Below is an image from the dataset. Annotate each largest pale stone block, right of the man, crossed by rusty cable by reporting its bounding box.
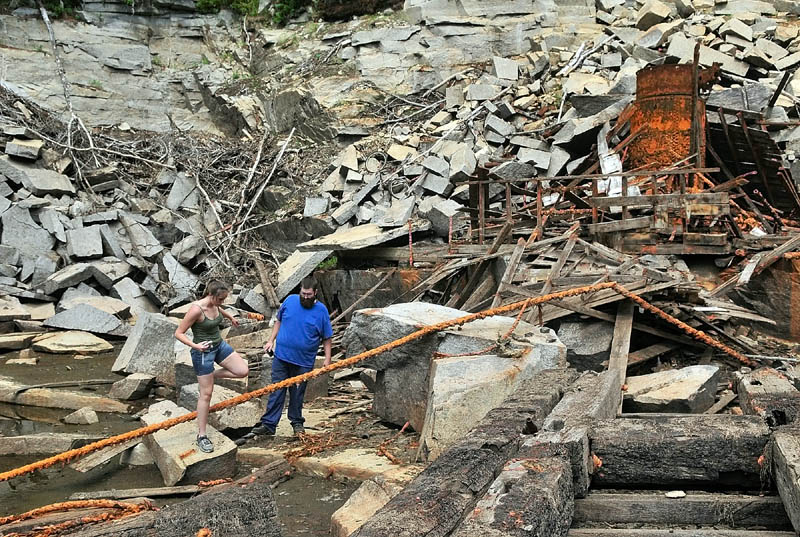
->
[344,302,566,457]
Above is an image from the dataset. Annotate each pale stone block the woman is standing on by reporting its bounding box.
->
[142,401,237,487]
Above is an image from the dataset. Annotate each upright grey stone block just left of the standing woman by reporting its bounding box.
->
[111,312,177,381]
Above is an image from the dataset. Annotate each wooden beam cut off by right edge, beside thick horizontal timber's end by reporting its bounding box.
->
[771,430,800,532]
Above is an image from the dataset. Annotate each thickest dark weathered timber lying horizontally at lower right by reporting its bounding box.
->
[590,414,770,488]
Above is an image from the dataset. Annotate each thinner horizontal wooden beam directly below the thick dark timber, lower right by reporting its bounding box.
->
[573,492,792,530]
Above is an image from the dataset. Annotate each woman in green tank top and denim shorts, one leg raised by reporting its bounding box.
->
[175,280,249,453]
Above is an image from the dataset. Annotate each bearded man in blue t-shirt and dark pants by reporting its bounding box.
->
[248,277,333,437]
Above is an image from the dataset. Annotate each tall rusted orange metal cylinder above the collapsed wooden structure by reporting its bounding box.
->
[626,64,706,170]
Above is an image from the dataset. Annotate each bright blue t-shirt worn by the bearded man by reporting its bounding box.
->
[275,295,333,367]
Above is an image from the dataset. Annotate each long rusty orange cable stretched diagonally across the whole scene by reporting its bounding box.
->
[0,282,754,482]
